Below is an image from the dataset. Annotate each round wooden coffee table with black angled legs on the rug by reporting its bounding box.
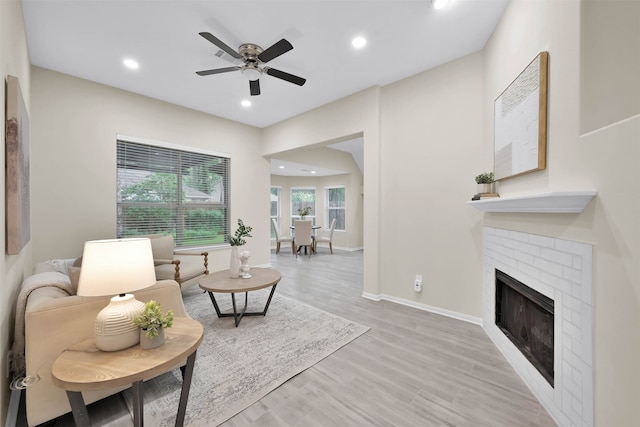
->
[200,268,282,328]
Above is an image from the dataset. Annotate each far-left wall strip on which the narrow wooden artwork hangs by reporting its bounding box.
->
[0,0,33,425]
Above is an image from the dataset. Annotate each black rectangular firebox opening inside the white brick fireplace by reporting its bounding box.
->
[496,270,553,386]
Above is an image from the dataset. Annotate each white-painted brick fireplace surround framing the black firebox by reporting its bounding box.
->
[483,227,593,427]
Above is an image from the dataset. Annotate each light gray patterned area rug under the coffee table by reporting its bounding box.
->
[126,290,369,426]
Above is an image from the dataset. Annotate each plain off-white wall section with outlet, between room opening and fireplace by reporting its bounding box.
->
[380,53,484,318]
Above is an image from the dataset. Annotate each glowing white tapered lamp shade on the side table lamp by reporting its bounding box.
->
[77,238,156,296]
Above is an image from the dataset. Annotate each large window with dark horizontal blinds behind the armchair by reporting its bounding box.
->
[117,140,229,248]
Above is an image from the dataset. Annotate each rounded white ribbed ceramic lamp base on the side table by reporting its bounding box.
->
[95,294,144,351]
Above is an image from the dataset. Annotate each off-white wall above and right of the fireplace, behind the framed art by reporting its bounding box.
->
[484,0,640,427]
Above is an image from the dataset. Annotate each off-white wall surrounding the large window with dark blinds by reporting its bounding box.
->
[32,67,270,271]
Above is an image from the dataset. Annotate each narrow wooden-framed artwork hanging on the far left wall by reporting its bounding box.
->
[5,76,31,255]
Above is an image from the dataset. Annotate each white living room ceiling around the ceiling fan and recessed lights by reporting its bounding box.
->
[23,0,508,176]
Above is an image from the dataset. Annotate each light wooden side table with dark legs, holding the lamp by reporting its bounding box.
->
[51,317,204,427]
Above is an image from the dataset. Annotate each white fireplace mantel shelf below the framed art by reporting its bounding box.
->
[467,191,596,213]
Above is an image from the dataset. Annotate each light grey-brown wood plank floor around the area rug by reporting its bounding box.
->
[23,247,556,427]
